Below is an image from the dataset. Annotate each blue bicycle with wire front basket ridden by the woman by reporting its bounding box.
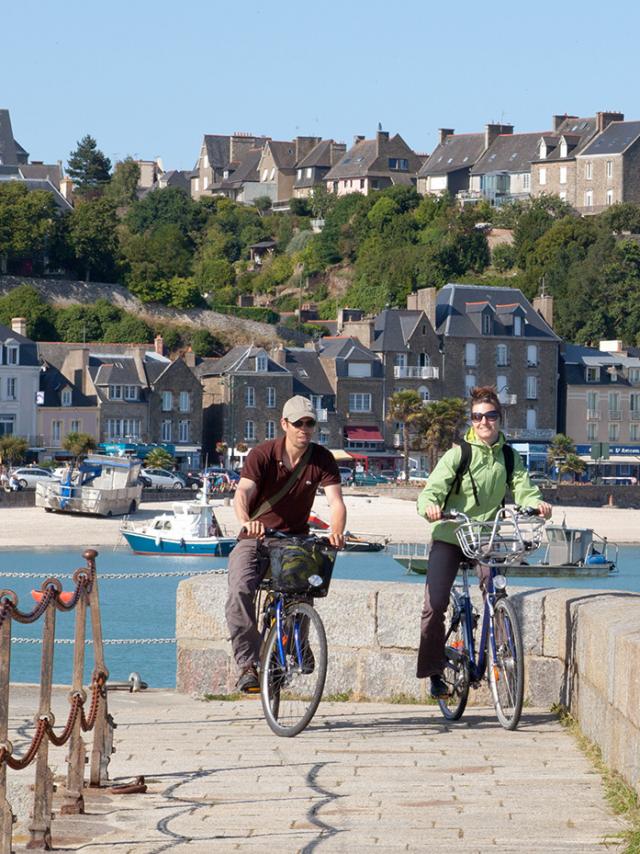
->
[438,507,544,730]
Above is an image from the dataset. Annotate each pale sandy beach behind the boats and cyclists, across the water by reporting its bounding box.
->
[0,495,640,552]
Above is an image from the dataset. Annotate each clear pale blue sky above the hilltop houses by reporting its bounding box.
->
[0,0,640,169]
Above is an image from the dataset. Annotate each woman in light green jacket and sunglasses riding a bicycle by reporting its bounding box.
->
[416,386,551,698]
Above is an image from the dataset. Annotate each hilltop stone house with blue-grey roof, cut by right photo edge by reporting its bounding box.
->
[576,121,640,215]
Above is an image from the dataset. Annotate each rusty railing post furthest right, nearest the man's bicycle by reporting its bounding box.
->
[82,549,113,786]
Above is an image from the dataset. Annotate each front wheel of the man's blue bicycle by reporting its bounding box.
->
[260,602,327,737]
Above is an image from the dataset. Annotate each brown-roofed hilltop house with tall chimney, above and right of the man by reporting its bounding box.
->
[325,130,424,196]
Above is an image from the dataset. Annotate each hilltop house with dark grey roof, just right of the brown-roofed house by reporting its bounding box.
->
[417,124,513,196]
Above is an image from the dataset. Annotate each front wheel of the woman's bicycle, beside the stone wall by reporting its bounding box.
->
[489,599,524,729]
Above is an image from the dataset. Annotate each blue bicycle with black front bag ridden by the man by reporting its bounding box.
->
[256,530,336,737]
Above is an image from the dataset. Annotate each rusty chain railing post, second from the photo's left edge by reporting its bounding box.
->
[27,592,60,851]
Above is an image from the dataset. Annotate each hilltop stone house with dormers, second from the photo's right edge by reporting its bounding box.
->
[531,112,624,207]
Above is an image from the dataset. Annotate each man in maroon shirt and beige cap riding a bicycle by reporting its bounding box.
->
[225,395,347,693]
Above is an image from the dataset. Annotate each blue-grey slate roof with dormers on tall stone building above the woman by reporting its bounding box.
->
[436,284,560,341]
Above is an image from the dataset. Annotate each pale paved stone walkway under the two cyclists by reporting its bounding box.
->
[9,689,622,854]
